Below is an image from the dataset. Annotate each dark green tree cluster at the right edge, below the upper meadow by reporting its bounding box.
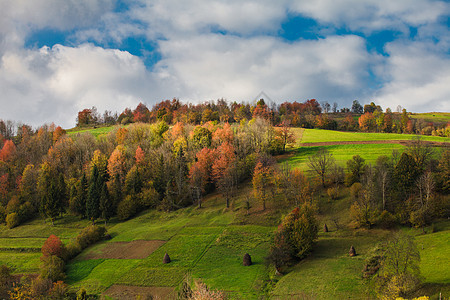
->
[309,137,450,228]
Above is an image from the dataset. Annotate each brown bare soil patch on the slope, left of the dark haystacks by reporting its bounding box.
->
[86,240,166,259]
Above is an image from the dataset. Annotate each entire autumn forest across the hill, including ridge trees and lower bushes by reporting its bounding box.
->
[0,99,450,299]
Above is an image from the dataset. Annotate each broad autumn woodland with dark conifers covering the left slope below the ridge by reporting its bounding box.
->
[0,118,293,228]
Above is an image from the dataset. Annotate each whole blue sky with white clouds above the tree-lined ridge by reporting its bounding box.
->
[0,0,450,128]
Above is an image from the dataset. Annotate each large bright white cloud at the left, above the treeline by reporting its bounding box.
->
[0,44,154,127]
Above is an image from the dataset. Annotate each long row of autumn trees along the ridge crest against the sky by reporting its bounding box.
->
[73,99,450,136]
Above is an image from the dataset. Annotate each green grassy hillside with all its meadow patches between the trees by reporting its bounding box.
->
[0,128,450,299]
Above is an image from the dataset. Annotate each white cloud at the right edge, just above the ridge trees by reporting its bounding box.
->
[375,42,450,112]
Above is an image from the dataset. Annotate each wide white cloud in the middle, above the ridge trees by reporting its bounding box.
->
[155,35,371,101]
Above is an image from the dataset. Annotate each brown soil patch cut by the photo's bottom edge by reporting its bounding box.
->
[103,285,177,300]
